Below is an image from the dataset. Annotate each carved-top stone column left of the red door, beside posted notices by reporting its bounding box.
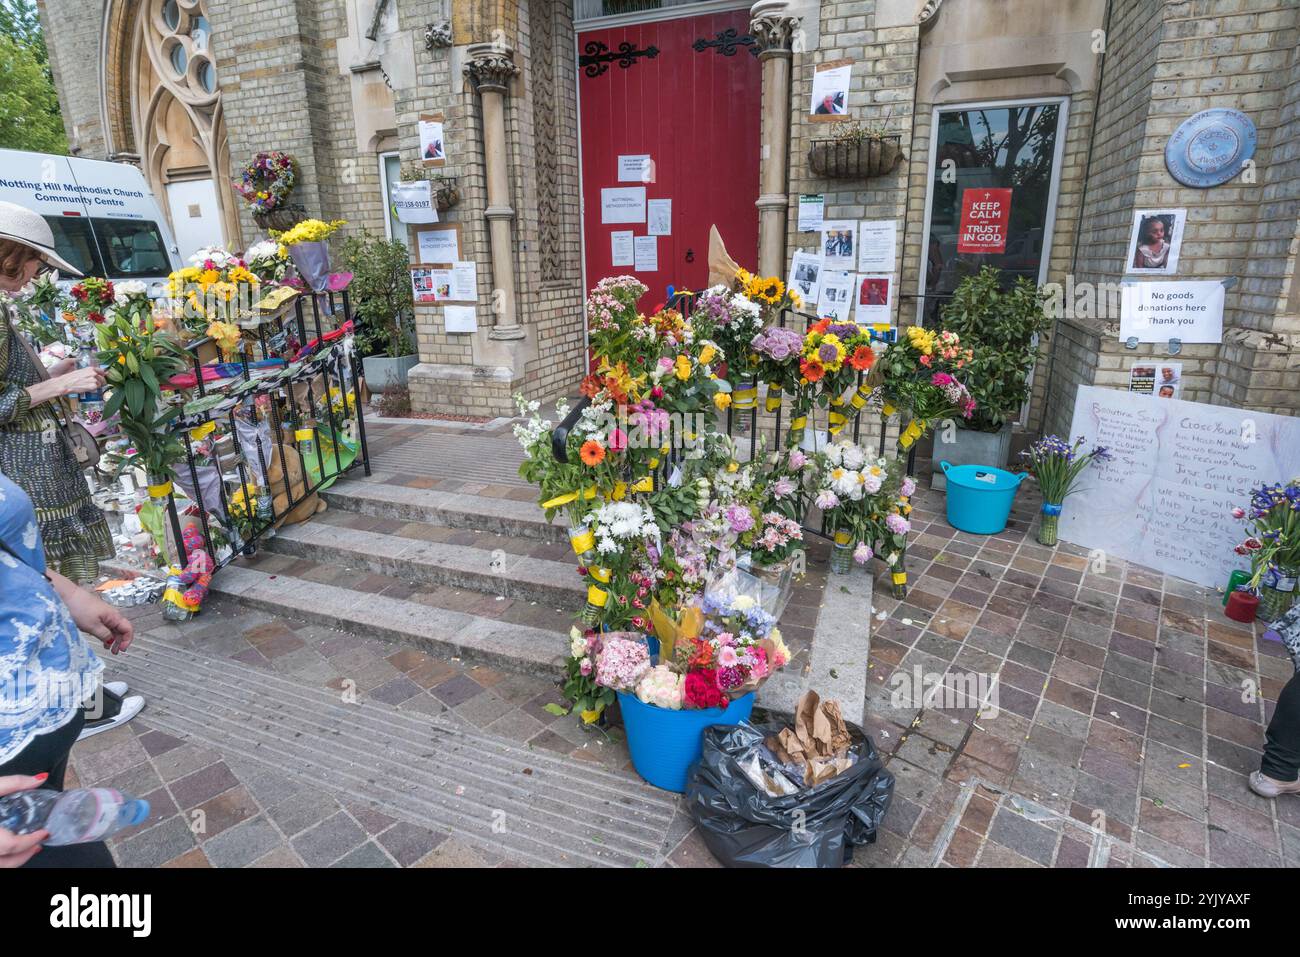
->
[464,43,524,339]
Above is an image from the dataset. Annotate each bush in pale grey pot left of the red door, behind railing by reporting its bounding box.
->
[343,231,420,393]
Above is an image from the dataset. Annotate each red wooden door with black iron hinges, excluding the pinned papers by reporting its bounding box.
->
[577,9,761,308]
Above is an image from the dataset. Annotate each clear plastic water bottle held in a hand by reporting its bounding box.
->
[0,788,150,848]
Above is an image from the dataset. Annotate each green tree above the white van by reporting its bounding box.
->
[0,0,68,155]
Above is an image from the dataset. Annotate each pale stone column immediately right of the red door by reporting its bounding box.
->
[749,0,798,276]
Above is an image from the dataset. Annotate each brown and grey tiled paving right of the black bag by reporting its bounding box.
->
[863,460,1300,866]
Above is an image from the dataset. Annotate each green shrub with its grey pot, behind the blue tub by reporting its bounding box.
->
[931,265,1050,489]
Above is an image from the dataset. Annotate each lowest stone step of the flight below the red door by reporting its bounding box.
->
[212,563,568,677]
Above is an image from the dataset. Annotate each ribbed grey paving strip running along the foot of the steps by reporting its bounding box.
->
[114,634,677,867]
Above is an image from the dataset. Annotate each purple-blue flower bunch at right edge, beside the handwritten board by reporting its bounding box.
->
[1232,479,1300,622]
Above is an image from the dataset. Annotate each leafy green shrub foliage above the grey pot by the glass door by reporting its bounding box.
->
[940,267,1050,432]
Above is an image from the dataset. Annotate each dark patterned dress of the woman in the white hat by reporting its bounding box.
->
[0,321,114,581]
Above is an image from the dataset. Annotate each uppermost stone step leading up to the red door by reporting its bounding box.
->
[321,476,568,542]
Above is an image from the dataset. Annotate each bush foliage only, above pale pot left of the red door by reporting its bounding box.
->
[342,230,415,359]
